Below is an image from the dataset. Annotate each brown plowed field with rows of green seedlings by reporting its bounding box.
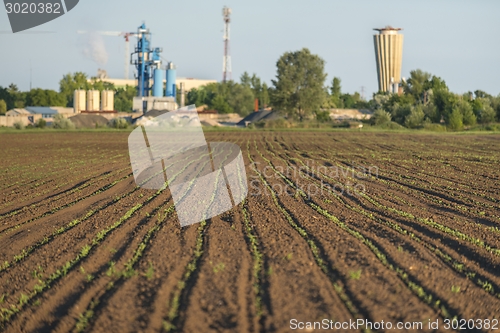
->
[0,131,500,332]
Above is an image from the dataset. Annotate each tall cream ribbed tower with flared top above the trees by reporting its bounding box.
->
[373,26,403,93]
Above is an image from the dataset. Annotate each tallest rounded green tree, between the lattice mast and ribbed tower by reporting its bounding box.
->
[272,48,326,121]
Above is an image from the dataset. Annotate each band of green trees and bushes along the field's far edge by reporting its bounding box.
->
[0,48,500,130]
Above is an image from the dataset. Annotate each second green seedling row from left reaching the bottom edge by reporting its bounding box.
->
[162,144,235,332]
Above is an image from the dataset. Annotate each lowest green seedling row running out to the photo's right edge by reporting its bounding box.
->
[274,140,500,298]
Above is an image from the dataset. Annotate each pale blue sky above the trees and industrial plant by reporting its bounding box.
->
[0,0,500,96]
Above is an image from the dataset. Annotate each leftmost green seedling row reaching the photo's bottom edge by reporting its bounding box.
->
[75,147,230,332]
